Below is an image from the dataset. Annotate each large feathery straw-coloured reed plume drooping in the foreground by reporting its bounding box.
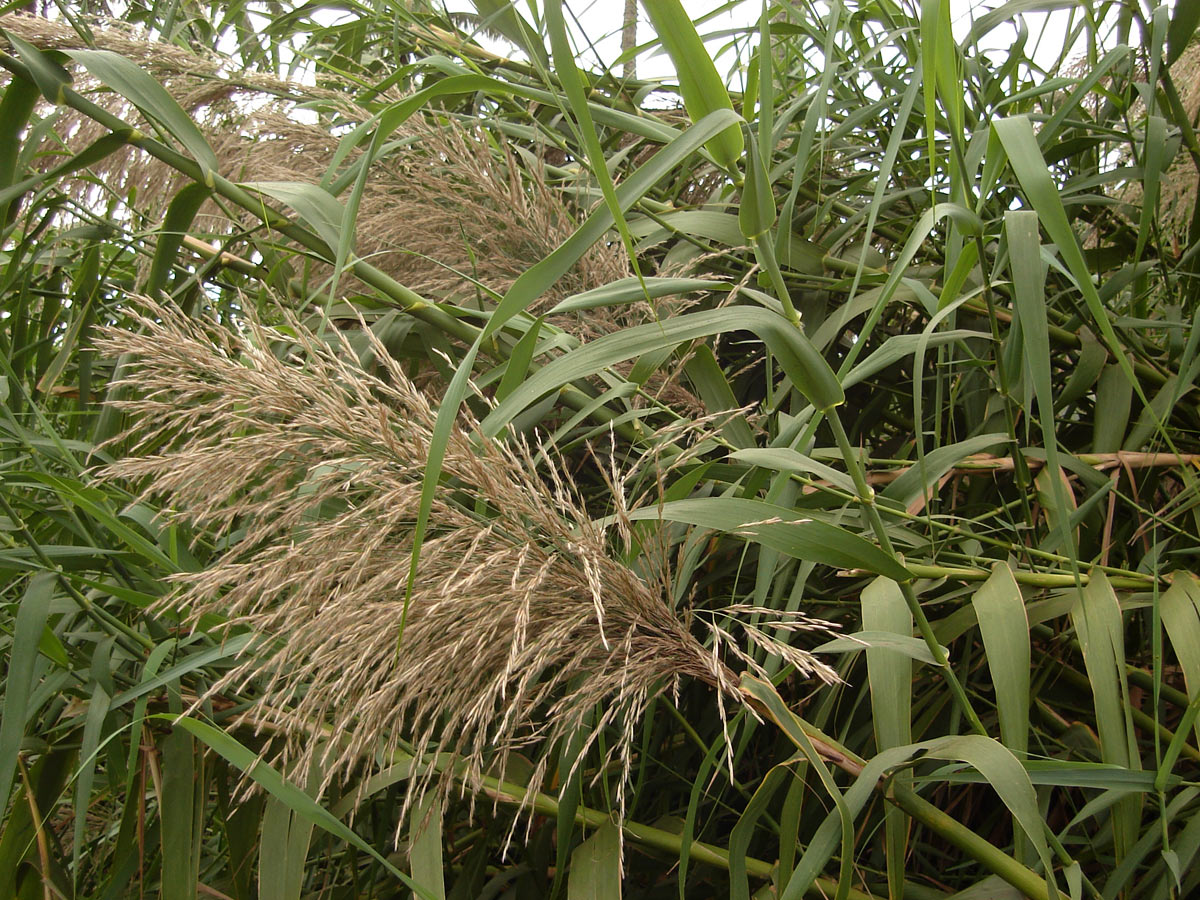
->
[93,301,830,835]
